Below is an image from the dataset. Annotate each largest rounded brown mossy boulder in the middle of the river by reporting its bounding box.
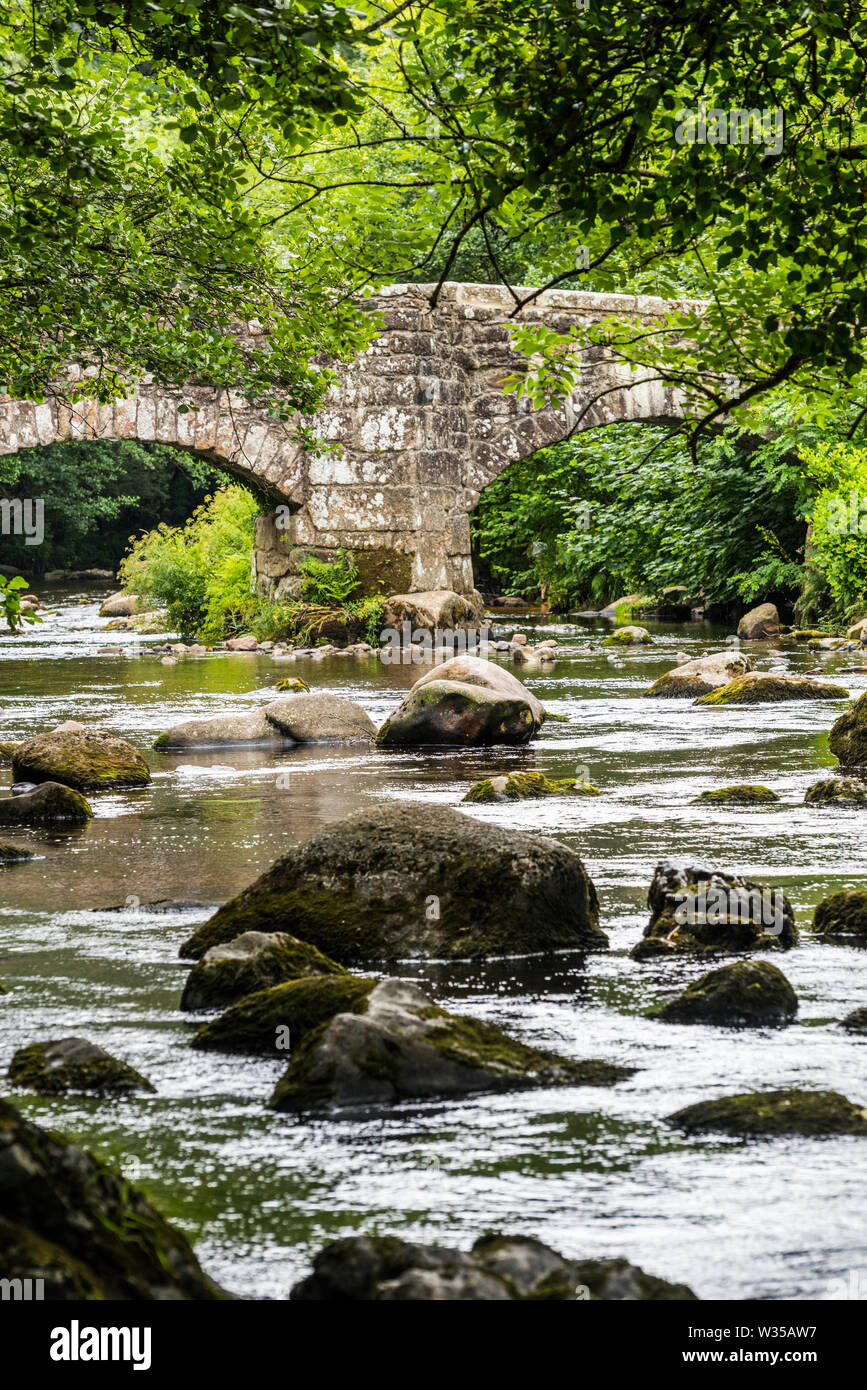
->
[181,802,607,965]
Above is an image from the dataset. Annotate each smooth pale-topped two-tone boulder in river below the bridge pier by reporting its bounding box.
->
[377,656,545,748]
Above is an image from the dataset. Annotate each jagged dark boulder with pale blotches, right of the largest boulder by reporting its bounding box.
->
[629,860,798,960]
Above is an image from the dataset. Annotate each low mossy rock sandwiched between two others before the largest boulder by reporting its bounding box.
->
[193,972,377,1056]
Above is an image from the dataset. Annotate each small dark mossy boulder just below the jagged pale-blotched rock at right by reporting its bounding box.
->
[653,960,798,1027]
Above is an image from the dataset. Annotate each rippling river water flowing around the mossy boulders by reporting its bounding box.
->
[0,596,867,1300]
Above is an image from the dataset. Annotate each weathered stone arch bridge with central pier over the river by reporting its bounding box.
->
[0,284,691,594]
